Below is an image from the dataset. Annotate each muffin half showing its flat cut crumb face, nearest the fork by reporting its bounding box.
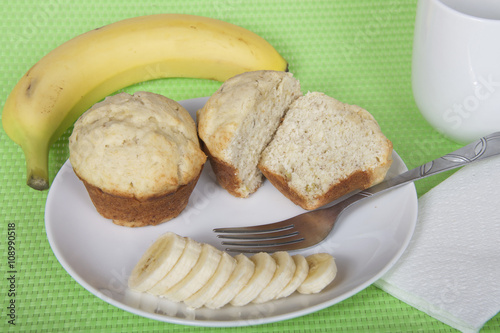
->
[258,92,392,210]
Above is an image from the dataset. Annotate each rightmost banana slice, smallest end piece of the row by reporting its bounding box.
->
[297,253,337,294]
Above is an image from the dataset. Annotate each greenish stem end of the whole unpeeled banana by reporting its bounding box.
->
[22,142,49,191]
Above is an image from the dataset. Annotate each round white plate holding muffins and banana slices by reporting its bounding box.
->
[45,98,417,326]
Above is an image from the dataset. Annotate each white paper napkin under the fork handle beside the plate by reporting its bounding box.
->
[375,156,500,332]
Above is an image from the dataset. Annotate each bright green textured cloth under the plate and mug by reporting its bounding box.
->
[0,0,500,332]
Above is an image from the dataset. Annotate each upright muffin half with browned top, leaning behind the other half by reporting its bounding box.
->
[197,71,302,197]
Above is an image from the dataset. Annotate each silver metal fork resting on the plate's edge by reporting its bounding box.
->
[213,132,500,253]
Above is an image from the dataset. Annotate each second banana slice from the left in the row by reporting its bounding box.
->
[148,237,201,296]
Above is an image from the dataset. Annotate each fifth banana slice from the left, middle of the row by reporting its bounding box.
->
[205,254,255,309]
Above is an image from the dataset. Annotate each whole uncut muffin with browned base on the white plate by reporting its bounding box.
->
[69,92,206,227]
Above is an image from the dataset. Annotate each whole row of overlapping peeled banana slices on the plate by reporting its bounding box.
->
[129,232,337,309]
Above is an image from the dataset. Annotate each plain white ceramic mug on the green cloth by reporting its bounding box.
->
[412,0,500,143]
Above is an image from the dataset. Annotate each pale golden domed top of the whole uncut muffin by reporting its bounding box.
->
[69,92,206,199]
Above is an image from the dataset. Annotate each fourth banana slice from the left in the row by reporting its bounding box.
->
[184,252,236,309]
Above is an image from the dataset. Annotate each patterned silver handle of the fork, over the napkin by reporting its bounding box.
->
[336,132,500,207]
